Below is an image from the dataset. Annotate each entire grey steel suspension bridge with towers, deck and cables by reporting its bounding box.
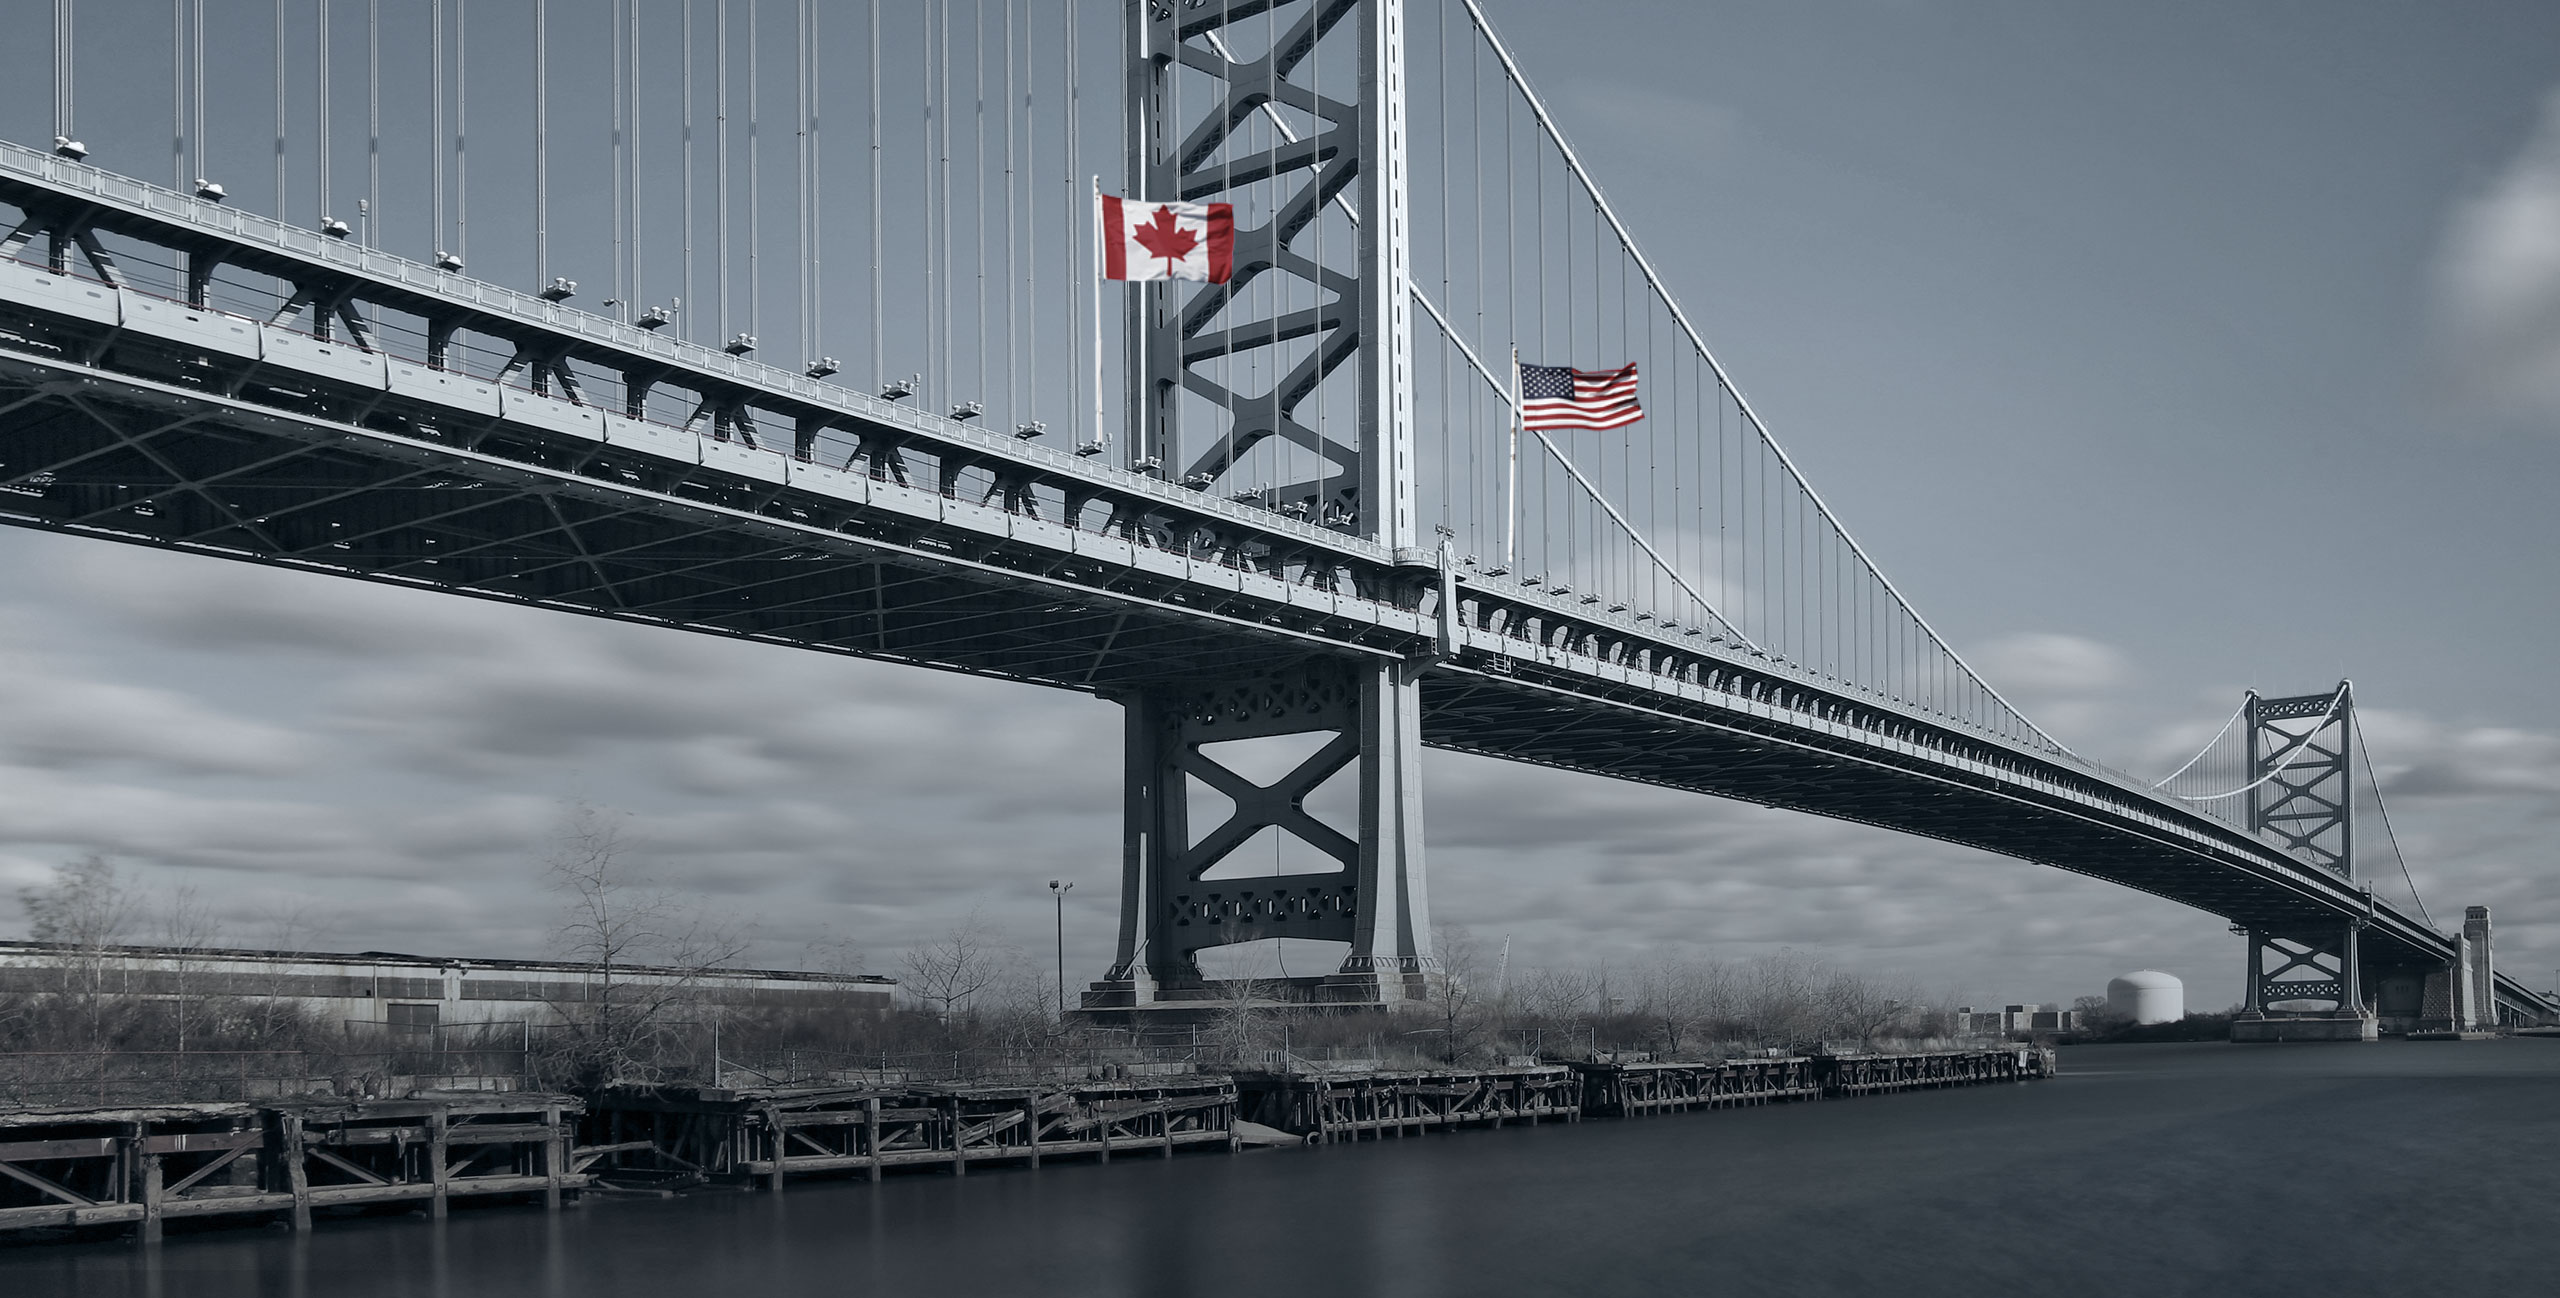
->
[0,0,2550,1037]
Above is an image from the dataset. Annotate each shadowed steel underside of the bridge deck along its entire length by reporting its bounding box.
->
[0,286,2529,1024]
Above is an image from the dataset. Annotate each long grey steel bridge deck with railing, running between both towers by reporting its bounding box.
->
[0,146,2529,1004]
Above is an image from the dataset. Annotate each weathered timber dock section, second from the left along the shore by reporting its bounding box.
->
[581,1075,1236,1190]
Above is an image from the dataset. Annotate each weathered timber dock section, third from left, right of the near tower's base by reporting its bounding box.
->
[1236,1065,1582,1144]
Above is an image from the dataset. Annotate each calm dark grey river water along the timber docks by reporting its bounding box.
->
[0,1039,2560,1298]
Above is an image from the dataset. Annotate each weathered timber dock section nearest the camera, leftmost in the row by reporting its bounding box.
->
[0,1093,586,1242]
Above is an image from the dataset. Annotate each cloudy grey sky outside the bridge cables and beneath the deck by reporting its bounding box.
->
[0,0,2560,1006]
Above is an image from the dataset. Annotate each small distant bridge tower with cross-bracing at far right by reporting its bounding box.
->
[2232,681,2375,1042]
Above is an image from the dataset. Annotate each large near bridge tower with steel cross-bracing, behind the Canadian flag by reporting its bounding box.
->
[1083,0,1444,1014]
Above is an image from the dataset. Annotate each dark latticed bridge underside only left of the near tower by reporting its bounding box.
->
[0,358,1339,691]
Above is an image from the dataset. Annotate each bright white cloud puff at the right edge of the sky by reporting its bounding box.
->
[2437,90,2560,433]
